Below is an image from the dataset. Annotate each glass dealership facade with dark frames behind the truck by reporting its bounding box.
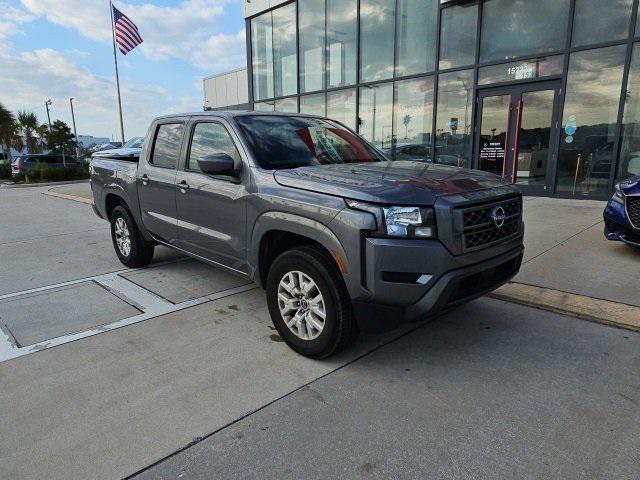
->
[247,0,640,198]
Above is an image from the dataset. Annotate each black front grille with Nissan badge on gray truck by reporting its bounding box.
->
[462,197,522,252]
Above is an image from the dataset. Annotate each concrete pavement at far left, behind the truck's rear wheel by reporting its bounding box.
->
[0,184,181,295]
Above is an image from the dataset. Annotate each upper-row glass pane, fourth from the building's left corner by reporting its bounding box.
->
[327,0,358,88]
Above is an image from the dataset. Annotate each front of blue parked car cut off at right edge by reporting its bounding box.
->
[604,175,640,247]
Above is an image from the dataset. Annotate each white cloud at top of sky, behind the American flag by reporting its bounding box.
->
[18,0,246,73]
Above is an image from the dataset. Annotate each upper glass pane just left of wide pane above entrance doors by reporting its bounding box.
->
[440,2,478,69]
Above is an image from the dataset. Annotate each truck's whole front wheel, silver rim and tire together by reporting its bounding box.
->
[266,246,358,358]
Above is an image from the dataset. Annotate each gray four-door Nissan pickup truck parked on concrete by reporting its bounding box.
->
[90,112,524,358]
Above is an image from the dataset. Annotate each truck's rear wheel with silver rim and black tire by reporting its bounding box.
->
[111,205,154,268]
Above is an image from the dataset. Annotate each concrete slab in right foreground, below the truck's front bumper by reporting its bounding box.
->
[135,299,640,480]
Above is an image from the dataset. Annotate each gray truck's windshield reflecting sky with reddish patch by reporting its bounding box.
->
[236,115,386,170]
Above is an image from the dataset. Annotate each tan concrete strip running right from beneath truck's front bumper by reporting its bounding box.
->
[488,282,640,332]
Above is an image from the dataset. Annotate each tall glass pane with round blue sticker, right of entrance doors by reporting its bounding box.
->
[556,45,627,195]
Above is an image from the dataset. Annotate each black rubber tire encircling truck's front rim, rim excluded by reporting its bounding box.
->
[266,246,359,359]
